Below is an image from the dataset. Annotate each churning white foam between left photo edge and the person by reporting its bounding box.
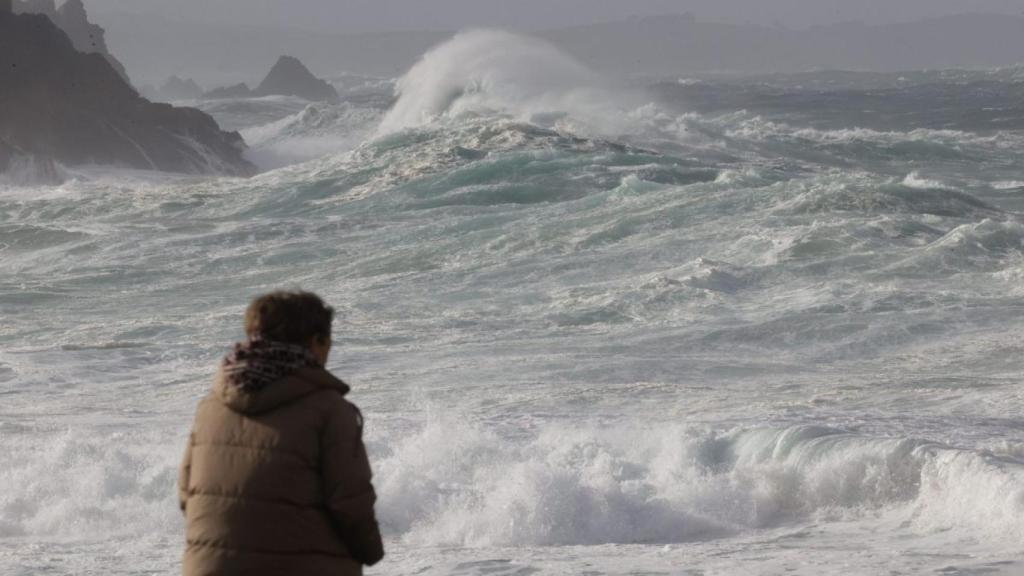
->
[0,424,181,540]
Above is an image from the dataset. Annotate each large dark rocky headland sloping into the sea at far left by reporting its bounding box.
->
[0,13,255,175]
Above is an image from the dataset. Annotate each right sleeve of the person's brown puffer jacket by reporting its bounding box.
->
[322,401,384,566]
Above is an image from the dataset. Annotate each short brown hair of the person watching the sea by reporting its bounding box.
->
[246,290,334,345]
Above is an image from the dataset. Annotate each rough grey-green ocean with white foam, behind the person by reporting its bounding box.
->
[0,31,1024,576]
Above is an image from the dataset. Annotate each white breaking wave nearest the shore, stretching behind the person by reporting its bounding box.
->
[0,419,1024,547]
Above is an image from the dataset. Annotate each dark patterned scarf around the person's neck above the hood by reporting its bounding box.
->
[221,340,319,393]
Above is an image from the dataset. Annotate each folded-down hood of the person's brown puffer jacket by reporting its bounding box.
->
[213,367,351,415]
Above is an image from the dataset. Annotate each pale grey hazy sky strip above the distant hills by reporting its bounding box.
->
[90,0,1024,33]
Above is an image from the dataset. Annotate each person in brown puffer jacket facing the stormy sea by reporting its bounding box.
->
[178,291,384,576]
